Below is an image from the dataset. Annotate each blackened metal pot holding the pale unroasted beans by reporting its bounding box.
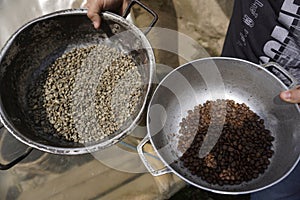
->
[0,8,155,155]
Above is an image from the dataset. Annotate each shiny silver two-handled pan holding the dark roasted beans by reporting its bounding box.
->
[138,58,300,194]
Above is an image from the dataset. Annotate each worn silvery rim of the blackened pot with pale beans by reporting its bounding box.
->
[0,9,156,155]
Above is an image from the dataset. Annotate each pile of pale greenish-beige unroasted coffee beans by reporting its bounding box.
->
[28,45,143,144]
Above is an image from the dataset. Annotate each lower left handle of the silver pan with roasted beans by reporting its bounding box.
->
[137,136,172,176]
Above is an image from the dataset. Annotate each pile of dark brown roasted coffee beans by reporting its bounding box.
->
[178,99,274,186]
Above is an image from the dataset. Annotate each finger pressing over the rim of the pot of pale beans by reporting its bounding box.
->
[86,0,105,29]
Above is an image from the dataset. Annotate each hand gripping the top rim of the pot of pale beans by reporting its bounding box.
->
[86,0,129,29]
